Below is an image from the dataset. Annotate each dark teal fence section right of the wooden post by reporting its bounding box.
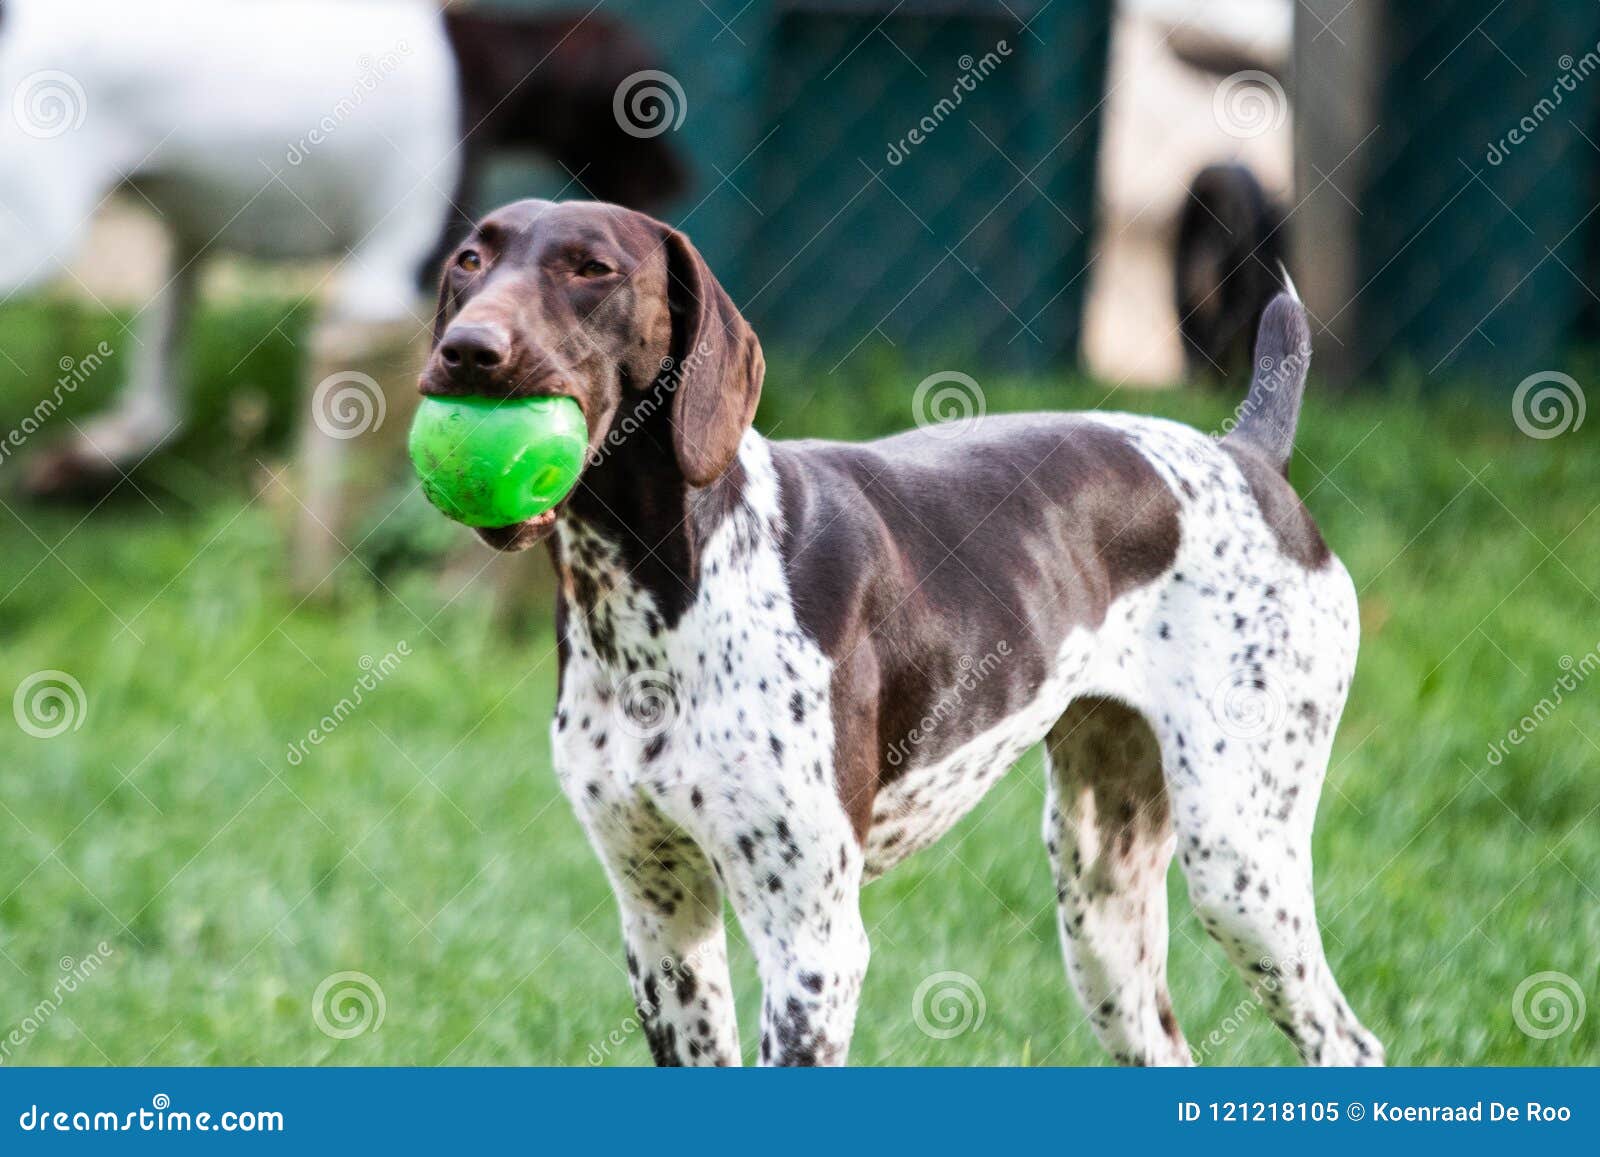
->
[1331,0,1600,387]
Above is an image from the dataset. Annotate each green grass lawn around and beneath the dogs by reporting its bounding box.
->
[0,300,1600,1064]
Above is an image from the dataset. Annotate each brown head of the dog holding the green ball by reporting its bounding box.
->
[421,200,765,549]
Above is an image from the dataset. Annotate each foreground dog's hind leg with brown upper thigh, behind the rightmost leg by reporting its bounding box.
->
[1045,699,1189,1064]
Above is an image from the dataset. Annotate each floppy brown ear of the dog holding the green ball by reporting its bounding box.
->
[664,229,766,486]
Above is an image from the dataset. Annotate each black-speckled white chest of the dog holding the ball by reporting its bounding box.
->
[552,435,834,823]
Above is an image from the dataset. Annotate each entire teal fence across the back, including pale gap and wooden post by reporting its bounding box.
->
[476,0,1600,387]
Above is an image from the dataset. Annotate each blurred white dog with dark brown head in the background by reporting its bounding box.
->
[0,0,682,584]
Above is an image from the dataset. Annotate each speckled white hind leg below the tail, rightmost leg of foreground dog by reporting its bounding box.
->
[1155,570,1384,1064]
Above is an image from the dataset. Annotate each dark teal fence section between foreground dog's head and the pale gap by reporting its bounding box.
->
[486,0,1110,368]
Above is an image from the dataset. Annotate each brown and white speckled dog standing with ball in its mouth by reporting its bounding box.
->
[421,202,1382,1064]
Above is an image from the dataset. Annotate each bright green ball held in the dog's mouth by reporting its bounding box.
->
[410,397,589,526]
